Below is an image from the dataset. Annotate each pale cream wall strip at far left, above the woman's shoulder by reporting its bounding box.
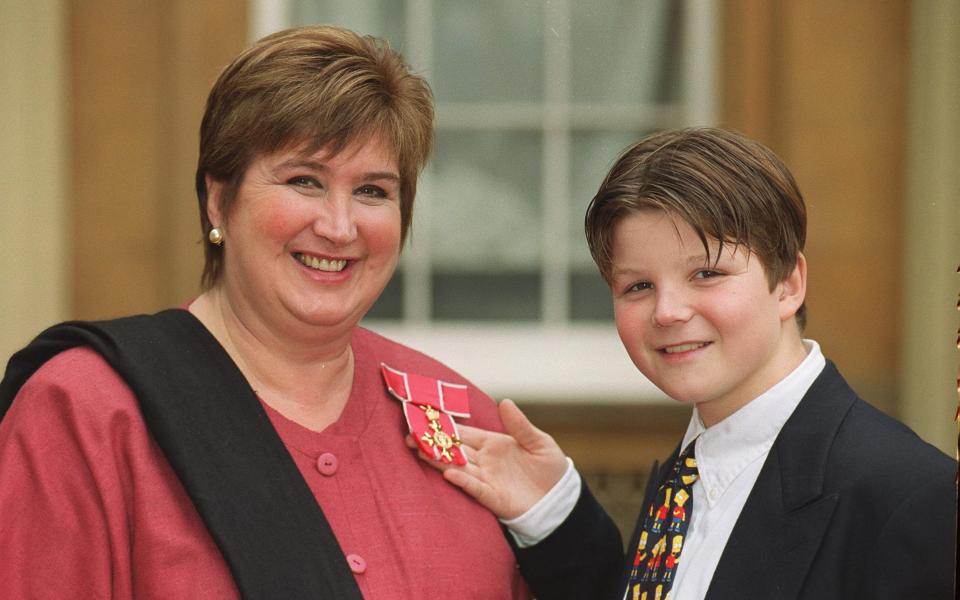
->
[0,0,72,364]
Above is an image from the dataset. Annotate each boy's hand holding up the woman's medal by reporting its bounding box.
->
[407,400,567,519]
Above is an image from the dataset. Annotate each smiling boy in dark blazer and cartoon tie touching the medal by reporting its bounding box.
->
[428,129,956,600]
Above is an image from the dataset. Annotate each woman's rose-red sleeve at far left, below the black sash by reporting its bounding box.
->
[0,354,120,598]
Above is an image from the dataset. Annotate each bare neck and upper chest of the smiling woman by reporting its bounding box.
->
[189,288,354,431]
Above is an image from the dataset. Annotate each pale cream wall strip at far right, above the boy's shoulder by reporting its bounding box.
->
[900,0,960,455]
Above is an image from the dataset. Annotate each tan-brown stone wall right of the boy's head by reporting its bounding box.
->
[722,0,909,412]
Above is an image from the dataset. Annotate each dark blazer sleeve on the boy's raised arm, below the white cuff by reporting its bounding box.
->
[507,482,623,600]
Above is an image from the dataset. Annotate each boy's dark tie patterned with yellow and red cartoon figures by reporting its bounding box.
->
[627,440,699,600]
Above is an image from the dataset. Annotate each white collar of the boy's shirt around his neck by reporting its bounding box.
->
[681,340,826,506]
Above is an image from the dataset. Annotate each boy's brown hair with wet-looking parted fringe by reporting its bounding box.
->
[584,128,807,329]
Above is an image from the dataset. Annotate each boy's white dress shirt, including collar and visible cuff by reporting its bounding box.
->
[503,340,826,600]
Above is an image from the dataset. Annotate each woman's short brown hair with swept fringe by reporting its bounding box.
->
[196,26,433,287]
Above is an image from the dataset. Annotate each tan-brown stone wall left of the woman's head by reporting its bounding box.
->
[68,0,246,318]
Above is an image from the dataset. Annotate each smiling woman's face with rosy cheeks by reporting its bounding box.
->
[208,137,400,335]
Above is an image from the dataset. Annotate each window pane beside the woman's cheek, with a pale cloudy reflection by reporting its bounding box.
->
[434,131,543,272]
